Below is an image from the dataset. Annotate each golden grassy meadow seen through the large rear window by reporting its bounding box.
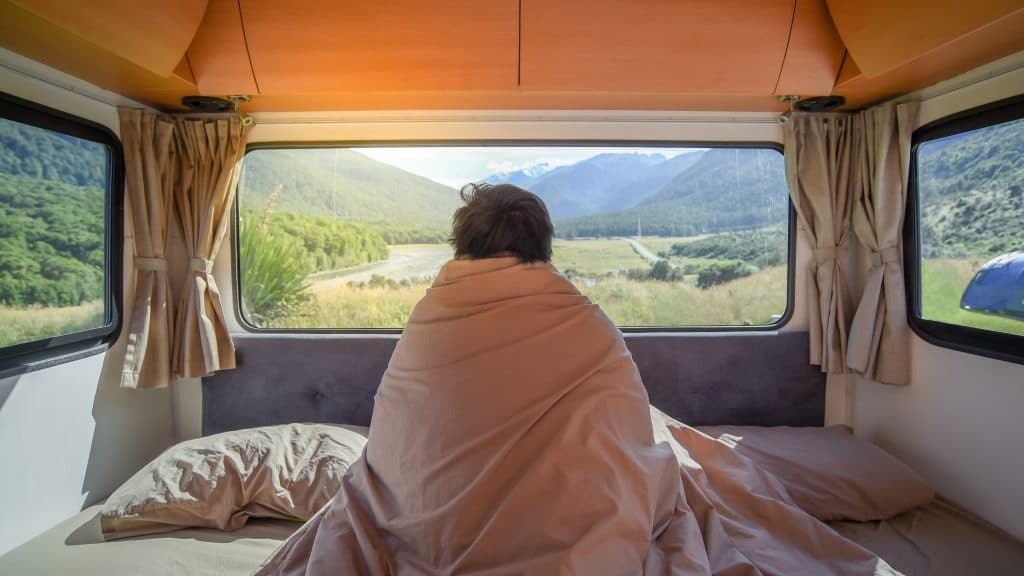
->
[261,238,786,329]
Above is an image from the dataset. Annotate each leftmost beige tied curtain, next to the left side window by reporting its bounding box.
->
[119,109,178,388]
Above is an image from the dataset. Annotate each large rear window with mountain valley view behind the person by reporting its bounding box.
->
[237,142,792,330]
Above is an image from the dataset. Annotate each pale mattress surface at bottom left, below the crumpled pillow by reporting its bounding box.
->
[0,504,301,576]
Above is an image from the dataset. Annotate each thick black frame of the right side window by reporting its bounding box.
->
[903,94,1024,364]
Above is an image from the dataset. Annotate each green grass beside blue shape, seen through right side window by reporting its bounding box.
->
[921,258,1024,335]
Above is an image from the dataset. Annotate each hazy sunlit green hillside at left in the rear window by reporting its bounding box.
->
[239,149,460,230]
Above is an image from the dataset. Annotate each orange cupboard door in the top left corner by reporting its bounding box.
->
[9,0,207,76]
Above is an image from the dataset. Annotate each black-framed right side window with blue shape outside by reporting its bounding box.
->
[908,96,1024,361]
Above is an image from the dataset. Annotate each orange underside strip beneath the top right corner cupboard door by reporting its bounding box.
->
[834,10,1024,109]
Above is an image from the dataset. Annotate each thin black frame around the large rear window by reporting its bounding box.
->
[231,139,797,335]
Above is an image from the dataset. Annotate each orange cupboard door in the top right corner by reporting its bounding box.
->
[828,0,1024,76]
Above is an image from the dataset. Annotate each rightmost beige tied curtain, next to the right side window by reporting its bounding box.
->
[847,102,918,384]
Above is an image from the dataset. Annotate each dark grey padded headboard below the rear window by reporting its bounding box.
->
[203,332,825,435]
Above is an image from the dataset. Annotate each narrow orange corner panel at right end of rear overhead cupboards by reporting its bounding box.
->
[775,0,846,96]
